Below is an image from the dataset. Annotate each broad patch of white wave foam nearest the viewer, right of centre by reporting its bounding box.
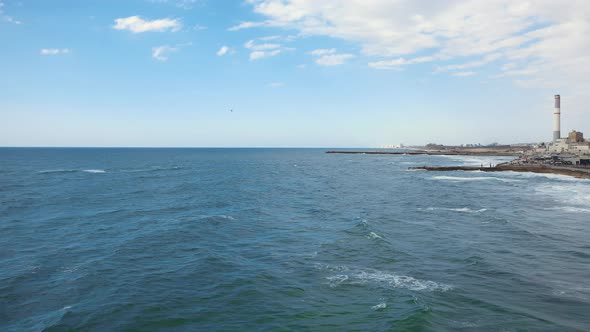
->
[319,264,453,292]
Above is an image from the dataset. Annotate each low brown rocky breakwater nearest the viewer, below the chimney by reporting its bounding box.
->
[410,164,590,179]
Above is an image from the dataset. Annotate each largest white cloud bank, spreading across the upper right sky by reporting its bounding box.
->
[239,0,590,93]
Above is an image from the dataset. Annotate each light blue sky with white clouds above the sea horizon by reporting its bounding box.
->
[0,0,590,147]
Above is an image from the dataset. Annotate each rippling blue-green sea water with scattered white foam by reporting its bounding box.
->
[0,148,590,331]
